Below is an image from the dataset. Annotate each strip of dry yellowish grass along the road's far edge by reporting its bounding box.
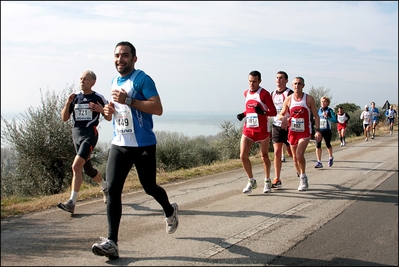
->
[1,125,397,219]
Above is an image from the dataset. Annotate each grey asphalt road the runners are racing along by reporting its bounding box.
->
[1,132,398,266]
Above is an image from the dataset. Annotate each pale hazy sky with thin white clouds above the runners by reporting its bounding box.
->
[1,1,398,118]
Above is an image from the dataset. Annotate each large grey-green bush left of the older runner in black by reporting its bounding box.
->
[1,86,75,196]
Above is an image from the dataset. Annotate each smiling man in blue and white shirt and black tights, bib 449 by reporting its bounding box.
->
[92,41,179,259]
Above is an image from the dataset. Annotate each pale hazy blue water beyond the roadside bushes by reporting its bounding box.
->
[99,111,243,143]
